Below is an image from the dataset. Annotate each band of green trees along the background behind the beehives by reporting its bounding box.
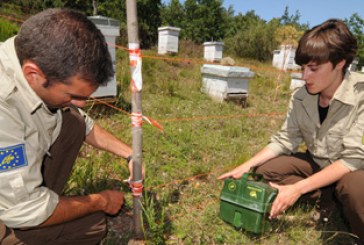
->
[5,0,364,66]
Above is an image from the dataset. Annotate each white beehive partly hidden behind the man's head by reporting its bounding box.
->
[88,16,120,98]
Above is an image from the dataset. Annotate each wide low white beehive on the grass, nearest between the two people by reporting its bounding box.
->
[201,64,254,102]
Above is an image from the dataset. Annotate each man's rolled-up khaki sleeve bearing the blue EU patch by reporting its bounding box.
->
[0,101,59,228]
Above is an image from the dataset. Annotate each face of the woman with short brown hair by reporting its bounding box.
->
[302,62,343,94]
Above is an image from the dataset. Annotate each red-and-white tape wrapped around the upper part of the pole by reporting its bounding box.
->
[129,43,143,92]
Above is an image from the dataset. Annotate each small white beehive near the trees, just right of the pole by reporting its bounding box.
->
[158,26,181,54]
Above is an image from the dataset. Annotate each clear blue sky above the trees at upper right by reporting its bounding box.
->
[223,0,364,27]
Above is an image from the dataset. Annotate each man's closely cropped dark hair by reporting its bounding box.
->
[15,9,114,86]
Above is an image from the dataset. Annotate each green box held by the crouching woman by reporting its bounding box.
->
[220,173,278,234]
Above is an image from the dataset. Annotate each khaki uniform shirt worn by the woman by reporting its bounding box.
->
[268,72,364,171]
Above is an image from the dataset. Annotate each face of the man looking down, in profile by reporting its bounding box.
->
[33,76,96,109]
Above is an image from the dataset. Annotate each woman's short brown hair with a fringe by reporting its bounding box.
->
[295,19,358,72]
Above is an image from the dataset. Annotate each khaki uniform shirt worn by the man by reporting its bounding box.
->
[0,38,93,228]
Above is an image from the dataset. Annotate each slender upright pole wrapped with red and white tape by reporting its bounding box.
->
[126,0,143,239]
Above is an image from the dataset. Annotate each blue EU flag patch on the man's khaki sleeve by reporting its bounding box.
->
[0,144,28,172]
